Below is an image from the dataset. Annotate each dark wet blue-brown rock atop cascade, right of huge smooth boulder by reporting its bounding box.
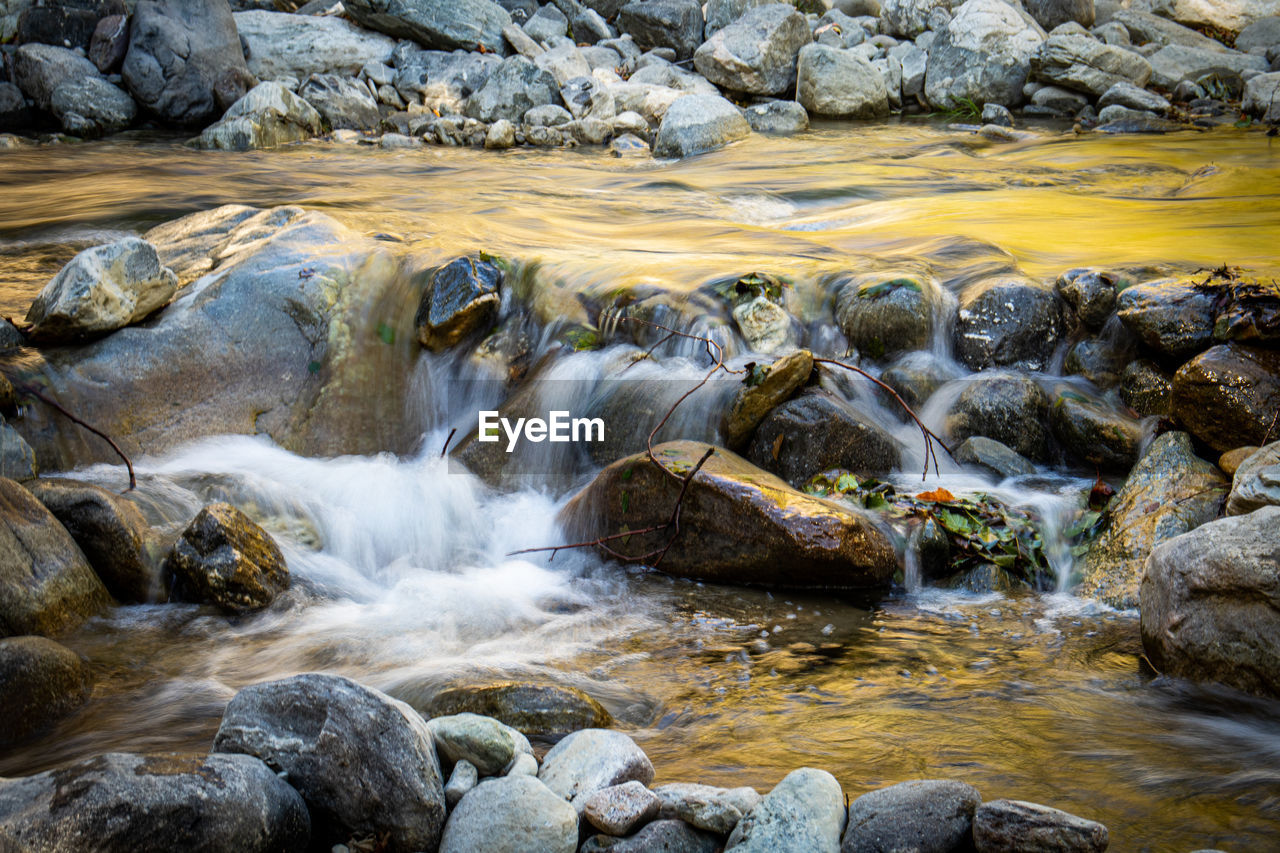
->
[413,257,502,352]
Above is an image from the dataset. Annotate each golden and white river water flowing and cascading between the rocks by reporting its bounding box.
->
[0,123,1280,850]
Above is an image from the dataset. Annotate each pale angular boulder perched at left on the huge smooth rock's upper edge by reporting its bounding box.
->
[27,237,178,342]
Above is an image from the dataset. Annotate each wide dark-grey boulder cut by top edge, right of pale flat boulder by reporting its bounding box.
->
[343,0,511,54]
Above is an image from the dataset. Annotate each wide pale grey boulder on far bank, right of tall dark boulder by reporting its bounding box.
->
[236,10,396,79]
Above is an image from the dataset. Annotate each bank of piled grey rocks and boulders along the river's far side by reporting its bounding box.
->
[0,0,1280,158]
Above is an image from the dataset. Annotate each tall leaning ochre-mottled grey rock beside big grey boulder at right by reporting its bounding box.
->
[1076,432,1226,607]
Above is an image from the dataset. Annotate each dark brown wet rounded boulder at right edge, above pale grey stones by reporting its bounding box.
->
[1174,343,1280,451]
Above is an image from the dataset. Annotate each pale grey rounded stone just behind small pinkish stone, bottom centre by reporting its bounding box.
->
[538,729,653,811]
